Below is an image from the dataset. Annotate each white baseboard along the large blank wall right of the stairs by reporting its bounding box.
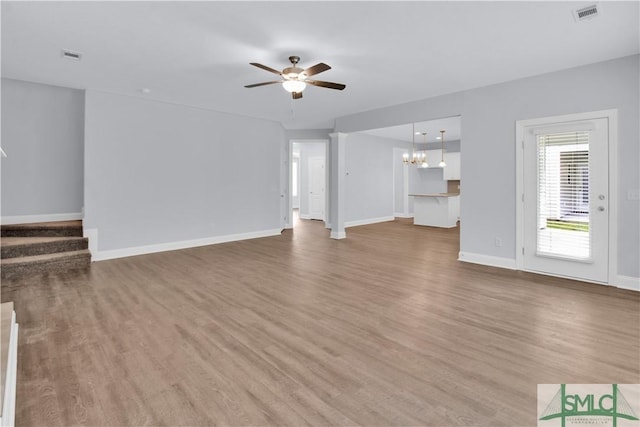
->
[89,228,282,261]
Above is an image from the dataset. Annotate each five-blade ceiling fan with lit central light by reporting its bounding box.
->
[245,56,347,99]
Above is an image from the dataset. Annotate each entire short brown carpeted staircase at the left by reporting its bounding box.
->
[0,221,91,279]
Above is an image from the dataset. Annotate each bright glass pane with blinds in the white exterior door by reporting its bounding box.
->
[537,132,591,261]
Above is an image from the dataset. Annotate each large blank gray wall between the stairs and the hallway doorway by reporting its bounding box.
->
[85,91,285,251]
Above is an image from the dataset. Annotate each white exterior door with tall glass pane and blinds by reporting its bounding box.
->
[523,118,609,283]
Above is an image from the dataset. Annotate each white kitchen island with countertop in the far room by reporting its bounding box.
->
[409,193,460,228]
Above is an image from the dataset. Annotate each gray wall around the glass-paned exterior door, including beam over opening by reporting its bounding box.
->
[336,55,640,277]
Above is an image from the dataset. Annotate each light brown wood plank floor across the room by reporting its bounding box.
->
[2,220,640,426]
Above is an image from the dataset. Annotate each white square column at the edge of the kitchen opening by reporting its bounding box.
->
[329,132,348,239]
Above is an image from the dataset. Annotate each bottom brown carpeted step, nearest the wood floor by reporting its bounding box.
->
[0,249,91,279]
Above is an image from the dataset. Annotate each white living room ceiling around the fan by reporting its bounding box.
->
[1,1,639,129]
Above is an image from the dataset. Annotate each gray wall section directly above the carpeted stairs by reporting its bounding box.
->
[2,78,84,221]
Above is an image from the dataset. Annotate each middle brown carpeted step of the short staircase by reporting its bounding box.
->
[0,236,89,259]
